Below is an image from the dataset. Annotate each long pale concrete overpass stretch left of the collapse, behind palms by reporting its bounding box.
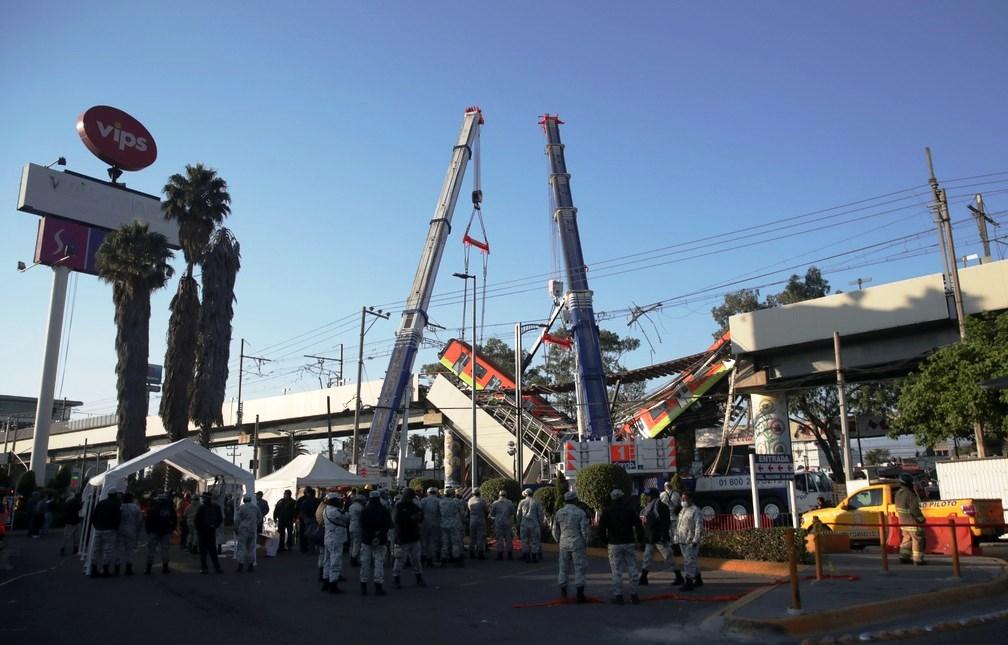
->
[7,377,440,463]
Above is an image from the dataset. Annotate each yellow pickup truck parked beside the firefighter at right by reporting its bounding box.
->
[801,482,1005,548]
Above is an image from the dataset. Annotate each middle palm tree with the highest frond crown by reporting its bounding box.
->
[159,163,231,440]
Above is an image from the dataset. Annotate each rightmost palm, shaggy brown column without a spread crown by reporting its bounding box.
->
[190,229,241,447]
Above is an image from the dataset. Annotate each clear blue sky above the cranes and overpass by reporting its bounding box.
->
[0,2,1008,421]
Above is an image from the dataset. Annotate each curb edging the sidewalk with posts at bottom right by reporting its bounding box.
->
[721,572,1008,640]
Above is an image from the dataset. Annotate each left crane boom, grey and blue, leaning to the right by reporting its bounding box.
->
[358,107,483,469]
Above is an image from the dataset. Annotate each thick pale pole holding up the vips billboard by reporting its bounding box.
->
[30,264,70,488]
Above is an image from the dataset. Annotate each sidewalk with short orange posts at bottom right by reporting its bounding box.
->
[718,551,1008,636]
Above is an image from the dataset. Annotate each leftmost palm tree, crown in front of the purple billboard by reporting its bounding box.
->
[96,222,174,462]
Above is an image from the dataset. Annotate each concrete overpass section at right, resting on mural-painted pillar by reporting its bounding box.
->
[729,260,1008,392]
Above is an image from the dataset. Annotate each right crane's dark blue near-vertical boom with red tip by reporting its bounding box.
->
[539,114,613,438]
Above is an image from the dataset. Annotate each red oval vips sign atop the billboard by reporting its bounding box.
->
[77,105,157,170]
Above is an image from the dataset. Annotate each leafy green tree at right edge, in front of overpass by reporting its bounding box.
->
[892,312,1008,453]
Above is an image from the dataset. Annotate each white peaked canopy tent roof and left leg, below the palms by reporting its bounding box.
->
[81,439,255,571]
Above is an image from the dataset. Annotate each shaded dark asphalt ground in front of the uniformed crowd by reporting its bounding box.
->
[0,534,763,645]
